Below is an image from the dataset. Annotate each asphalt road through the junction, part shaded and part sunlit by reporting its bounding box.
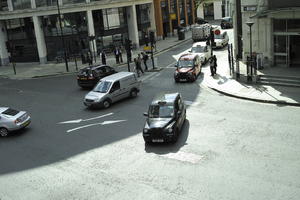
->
[0,38,300,200]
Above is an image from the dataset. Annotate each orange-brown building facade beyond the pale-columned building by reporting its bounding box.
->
[154,0,195,39]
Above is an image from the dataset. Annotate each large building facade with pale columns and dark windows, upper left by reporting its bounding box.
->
[0,0,156,65]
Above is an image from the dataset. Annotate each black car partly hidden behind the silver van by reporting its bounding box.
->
[77,65,117,88]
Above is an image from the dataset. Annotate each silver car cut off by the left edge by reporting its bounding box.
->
[0,107,31,137]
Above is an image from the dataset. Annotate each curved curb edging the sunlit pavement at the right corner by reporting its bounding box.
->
[207,85,300,107]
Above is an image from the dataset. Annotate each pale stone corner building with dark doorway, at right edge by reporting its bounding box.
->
[233,0,300,67]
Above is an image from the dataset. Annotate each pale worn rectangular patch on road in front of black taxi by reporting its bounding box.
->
[160,151,204,164]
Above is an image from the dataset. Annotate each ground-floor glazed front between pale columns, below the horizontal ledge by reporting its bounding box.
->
[0,3,155,65]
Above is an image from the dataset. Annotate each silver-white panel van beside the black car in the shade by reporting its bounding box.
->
[83,72,141,108]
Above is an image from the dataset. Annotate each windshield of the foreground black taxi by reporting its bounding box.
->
[149,105,174,118]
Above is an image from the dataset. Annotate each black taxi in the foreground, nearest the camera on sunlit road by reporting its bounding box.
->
[143,93,186,143]
